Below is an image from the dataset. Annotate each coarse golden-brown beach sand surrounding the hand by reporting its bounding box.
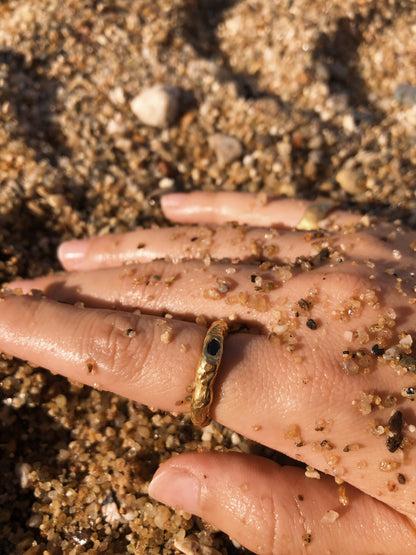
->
[0,0,416,555]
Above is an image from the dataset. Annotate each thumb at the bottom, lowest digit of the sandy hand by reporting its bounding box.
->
[149,452,416,555]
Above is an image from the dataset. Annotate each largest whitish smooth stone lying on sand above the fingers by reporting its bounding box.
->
[130,85,181,128]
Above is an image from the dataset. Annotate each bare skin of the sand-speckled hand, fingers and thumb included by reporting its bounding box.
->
[0,193,416,554]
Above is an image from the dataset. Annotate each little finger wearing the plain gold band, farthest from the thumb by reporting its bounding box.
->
[161,191,360,229]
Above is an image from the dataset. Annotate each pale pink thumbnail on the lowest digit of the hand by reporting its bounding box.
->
[149,467,201,513]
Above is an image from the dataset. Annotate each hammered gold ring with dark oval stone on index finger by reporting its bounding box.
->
[191,320,228,426]
